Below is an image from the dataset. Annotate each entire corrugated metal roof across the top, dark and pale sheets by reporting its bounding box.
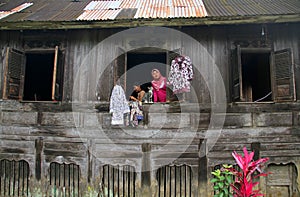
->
[0,0,300,22]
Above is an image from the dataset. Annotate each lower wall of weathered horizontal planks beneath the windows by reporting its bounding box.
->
[0,101,300,196]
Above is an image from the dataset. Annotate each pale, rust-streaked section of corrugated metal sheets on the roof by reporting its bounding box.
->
[77,0,207,20]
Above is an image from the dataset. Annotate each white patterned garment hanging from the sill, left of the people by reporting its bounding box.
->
[109,85,130,125]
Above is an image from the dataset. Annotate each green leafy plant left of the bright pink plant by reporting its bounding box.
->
[211,164,233,197]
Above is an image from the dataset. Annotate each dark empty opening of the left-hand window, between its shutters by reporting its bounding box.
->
[23,52,54,101]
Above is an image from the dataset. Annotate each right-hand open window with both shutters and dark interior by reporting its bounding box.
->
[232,46,295,102]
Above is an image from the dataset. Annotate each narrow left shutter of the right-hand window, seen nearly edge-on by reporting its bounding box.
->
[231,45,243,101]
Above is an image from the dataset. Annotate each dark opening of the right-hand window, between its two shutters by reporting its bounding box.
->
[241,53,272,102]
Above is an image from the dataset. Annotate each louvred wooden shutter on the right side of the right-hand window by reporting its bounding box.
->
[272,49,296,101]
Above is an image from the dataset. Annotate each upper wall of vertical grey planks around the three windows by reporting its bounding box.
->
[0,24,300,103]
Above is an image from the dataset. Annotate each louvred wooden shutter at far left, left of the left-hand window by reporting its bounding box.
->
[3,48,26,100]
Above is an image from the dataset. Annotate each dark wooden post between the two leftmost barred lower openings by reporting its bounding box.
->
[35,137,44,181]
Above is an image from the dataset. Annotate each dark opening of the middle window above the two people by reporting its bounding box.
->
[126,52,167,97]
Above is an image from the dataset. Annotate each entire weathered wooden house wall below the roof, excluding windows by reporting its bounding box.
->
[0,24,300,197]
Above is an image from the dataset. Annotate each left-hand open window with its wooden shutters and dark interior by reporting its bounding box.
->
[3,47,63,101]
